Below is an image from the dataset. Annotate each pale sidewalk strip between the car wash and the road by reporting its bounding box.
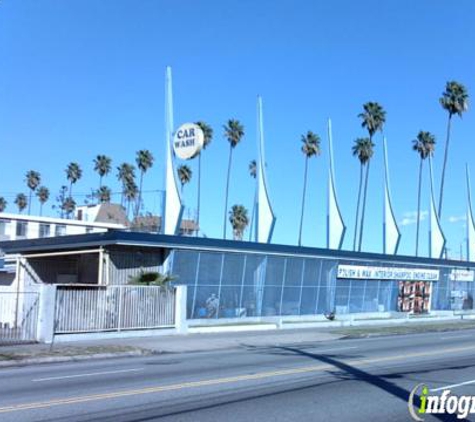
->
[0,321,475,368]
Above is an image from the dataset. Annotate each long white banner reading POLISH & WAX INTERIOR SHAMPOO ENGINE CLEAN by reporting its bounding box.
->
[337,265,439,281]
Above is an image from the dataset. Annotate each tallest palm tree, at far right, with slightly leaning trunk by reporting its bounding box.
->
[438,81,468,218]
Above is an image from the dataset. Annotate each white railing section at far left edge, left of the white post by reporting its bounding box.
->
[0,292,39,345]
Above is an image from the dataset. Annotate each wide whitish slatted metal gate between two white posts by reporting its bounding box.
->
[54,285,175,334]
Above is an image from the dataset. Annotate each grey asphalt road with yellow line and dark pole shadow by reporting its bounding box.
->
[0,330,475,422]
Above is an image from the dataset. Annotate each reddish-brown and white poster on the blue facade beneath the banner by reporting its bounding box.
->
[398,281,432,314]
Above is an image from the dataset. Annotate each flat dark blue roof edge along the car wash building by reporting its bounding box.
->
[0,230,475,267]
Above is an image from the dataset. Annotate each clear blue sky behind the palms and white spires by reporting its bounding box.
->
[0,0,475,257]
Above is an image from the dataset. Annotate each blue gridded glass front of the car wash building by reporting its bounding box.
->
[171,250,475,319]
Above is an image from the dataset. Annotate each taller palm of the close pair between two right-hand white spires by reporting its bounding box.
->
[358,101,386,251]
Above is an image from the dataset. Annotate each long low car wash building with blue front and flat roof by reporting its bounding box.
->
[0,231,475,319]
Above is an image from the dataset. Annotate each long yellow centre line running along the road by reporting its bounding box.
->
[0,346,475,413]
